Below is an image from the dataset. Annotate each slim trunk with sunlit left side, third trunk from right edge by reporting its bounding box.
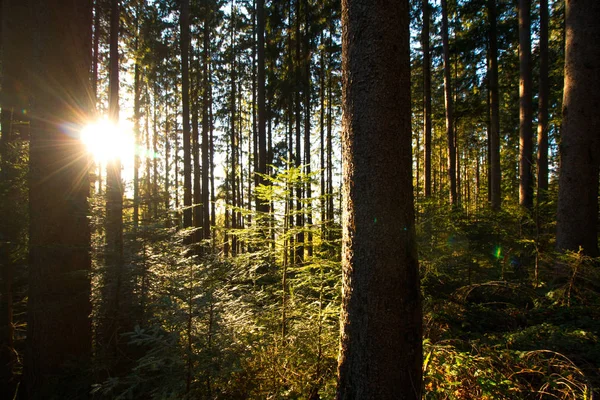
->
[519,0,533,210]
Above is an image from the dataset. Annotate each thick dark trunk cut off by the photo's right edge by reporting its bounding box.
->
[556,0,600,257]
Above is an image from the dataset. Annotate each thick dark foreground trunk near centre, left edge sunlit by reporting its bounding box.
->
[337,0,423,400]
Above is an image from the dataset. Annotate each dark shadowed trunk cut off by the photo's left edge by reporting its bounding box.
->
[0,0,31,398]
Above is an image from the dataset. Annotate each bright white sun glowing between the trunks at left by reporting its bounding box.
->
[81,119,135,163]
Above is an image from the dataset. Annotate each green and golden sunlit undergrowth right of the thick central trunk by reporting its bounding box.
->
[418,203,600,399]
